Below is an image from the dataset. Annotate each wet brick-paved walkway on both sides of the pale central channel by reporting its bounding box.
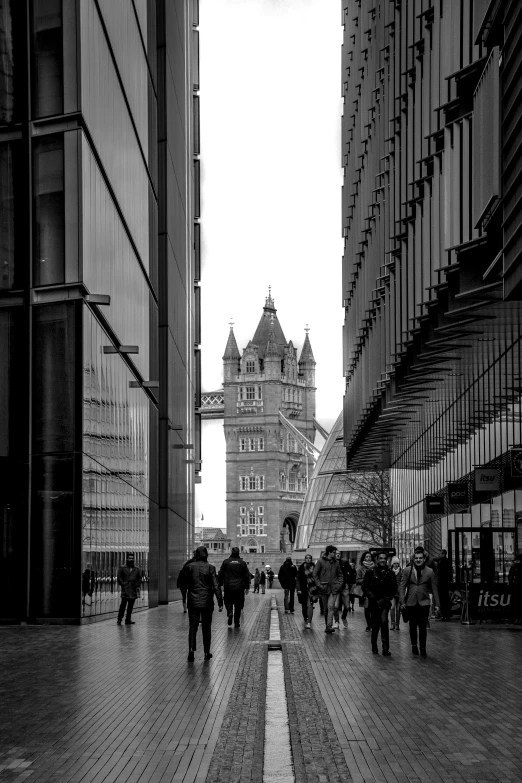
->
[0,591,522,783]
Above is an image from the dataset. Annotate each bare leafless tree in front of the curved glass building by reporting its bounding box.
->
[345,469,393,546]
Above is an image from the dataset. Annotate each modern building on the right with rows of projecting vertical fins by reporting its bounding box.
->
[342,0,522,582]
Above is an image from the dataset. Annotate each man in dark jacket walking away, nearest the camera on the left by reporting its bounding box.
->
[180,546,223,661]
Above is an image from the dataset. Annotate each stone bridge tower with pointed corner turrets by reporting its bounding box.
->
[223,292,315,568]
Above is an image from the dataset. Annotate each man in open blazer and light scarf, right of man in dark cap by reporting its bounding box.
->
[399,547,440,658]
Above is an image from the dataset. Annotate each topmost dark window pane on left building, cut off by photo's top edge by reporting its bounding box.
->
[33,0,63,117]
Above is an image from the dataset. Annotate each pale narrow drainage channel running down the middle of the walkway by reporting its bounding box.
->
[263,598,295,783]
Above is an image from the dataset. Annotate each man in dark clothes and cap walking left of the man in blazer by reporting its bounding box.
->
[362,552,397,656]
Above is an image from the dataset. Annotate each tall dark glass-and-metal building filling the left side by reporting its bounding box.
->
[0,0,201,622]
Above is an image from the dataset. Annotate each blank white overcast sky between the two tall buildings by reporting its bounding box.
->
[196,0,344,528]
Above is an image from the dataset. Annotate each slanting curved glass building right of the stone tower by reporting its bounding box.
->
[295,413,368,550]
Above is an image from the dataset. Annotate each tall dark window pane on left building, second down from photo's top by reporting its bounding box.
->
[34,135,65,285]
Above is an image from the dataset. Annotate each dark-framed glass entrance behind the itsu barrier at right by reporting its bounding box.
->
[448,527,518,584]
